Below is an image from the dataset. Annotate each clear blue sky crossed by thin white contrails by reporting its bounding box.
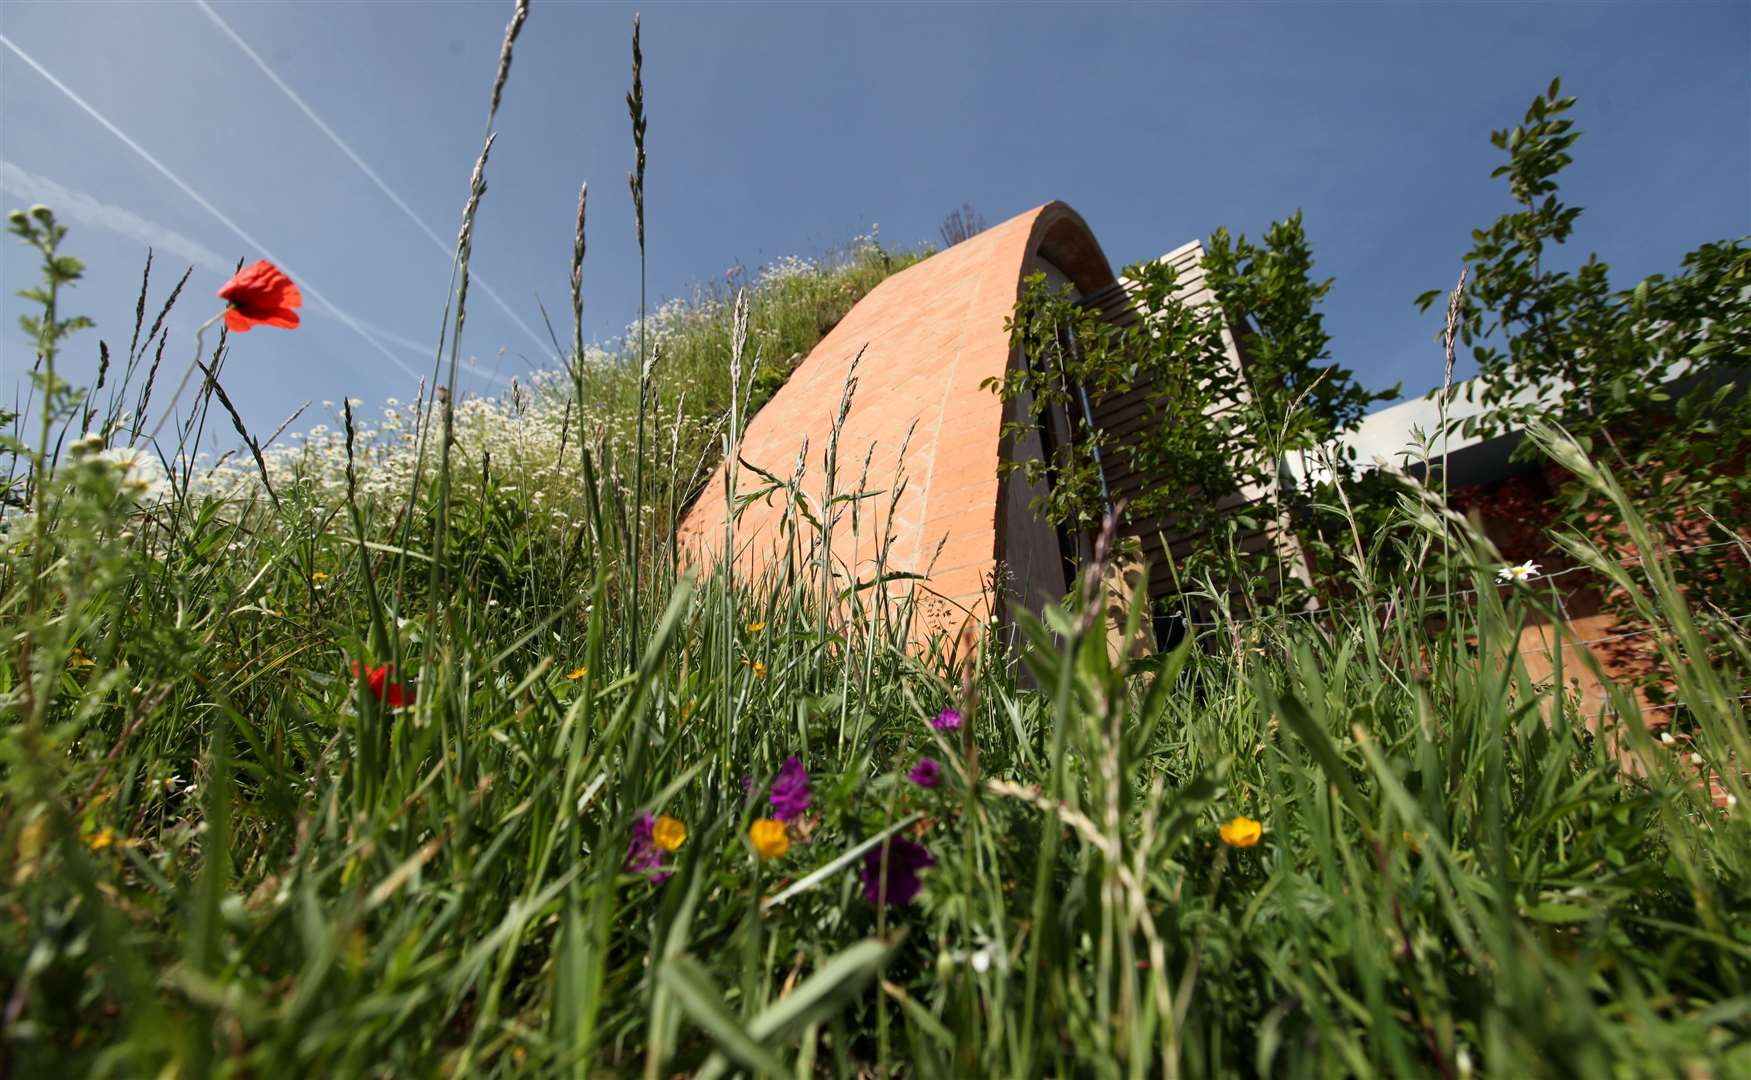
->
[0,0,1751,437]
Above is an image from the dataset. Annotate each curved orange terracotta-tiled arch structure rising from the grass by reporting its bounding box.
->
[679,203,1114,641]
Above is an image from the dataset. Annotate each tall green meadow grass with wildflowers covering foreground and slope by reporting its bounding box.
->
[0,6,1751,1076]
